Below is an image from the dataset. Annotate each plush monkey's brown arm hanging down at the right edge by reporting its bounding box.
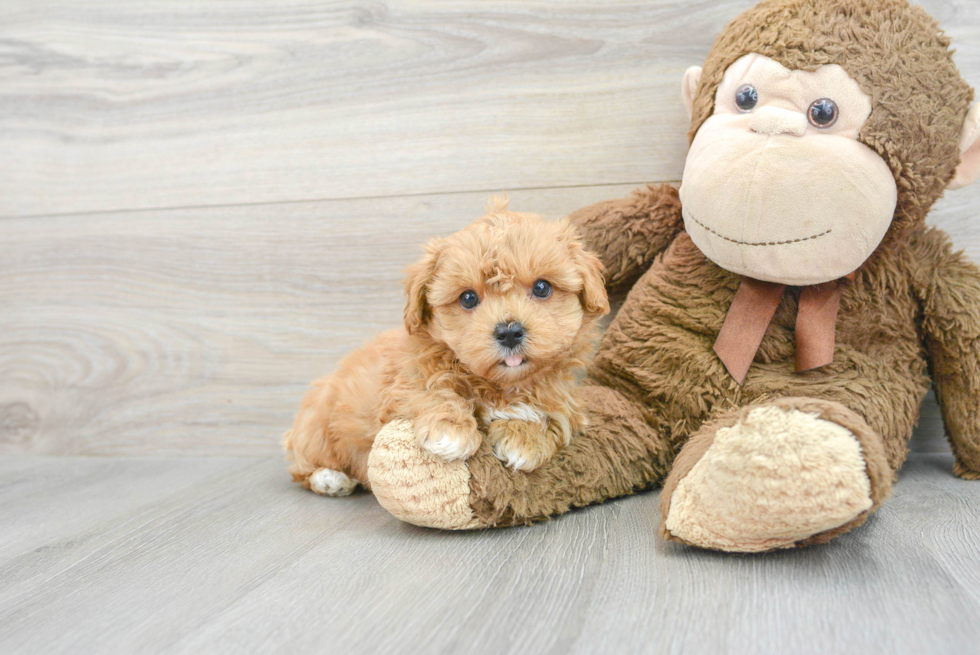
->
[913,229,980,480]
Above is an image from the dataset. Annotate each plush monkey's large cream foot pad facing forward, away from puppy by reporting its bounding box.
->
[661,405,877,552]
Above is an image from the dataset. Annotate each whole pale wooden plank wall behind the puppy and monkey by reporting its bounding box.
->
[0,0,980,455]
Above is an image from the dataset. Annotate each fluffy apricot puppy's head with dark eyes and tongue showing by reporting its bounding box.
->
[405,208,609,383]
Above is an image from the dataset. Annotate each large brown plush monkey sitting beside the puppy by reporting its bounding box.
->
[369,0,980,552]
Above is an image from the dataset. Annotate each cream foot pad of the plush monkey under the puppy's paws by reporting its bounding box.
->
[368,421,486,530]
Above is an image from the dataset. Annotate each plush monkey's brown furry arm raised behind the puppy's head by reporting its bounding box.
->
[569,184,684,292]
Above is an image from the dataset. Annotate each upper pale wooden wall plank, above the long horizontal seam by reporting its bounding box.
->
[0,0,980,216]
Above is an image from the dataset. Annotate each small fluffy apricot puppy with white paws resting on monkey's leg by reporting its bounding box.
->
[283,198,609,496]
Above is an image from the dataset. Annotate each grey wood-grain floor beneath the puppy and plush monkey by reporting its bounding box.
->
[0,454,980,655]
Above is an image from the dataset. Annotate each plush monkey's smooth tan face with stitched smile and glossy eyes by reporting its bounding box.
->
[680,54,898,285]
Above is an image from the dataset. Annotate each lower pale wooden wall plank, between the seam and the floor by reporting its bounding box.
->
[0,185,980,455]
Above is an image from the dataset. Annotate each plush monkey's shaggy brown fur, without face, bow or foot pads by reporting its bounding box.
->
[366,0,980,550]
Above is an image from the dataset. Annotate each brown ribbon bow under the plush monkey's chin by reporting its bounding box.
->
[715,273,854,384]
